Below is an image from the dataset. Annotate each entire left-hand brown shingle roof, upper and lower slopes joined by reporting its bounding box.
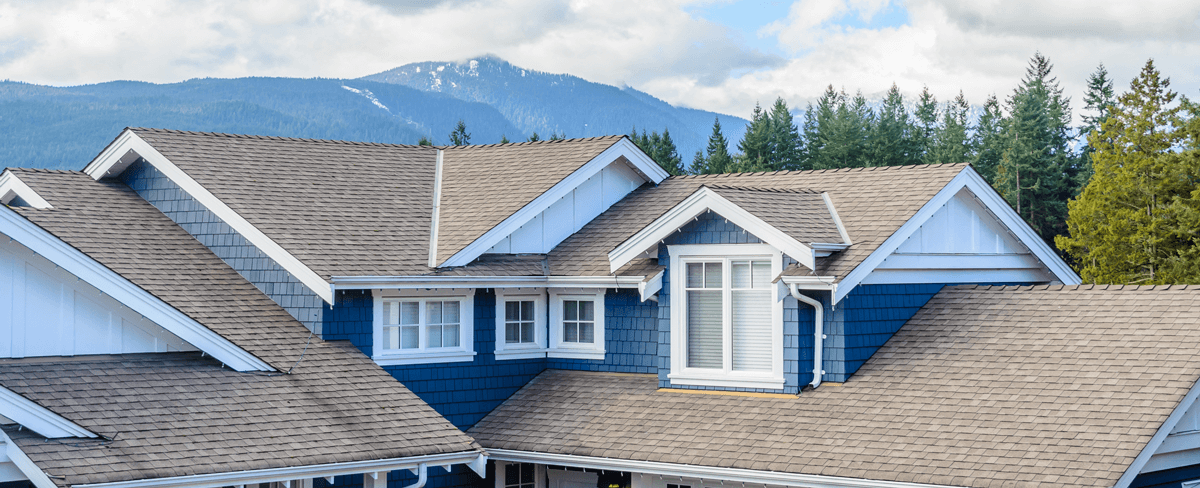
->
[0,169,475,484]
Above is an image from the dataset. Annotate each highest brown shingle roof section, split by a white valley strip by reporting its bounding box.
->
[130,128,623,276]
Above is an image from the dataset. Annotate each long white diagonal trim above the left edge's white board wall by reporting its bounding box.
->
[0,209,274,372]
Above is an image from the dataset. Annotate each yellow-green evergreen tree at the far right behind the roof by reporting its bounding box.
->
[1056,60,1200,283]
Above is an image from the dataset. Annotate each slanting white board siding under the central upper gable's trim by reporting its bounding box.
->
[487,161,646,254]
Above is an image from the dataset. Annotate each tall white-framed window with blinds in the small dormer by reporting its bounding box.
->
[668,245,784,388]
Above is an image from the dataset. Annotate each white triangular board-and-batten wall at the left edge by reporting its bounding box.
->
[0,234,197,357]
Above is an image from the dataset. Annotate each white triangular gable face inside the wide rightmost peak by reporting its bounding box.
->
[862,188,1055,284]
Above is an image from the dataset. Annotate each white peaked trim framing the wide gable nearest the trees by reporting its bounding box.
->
[833,165,1081,303]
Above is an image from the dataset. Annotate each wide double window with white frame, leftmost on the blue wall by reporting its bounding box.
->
[373,290,475,366]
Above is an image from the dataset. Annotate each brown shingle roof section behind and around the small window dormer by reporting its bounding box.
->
[547,164,966,277]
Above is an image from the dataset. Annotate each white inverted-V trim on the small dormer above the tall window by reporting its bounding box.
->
[608,187,816,272]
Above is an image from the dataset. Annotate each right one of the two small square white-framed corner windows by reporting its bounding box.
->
[547,289,605,360]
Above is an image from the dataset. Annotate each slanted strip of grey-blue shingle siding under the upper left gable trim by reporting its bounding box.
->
[119,159,325,335]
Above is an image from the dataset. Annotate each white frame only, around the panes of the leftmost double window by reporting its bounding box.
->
[371,289,475,366]
